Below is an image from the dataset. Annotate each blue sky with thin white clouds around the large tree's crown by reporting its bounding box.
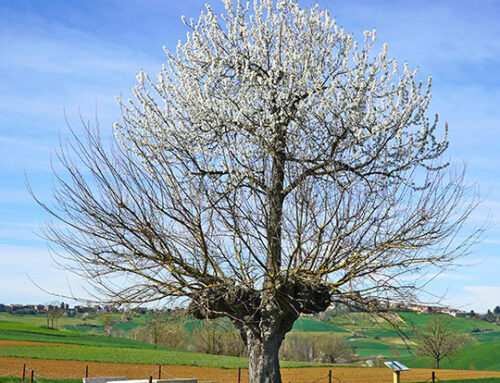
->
[0,0,500,312]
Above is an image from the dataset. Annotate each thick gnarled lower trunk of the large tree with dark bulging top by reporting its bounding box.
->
[189,277,332,383]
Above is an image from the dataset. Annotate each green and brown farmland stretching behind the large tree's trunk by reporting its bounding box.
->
[0,313,500,383]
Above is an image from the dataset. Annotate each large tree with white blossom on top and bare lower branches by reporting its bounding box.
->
[32,0,477,383]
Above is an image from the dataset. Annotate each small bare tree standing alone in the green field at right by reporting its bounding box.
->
[414,315,472,369]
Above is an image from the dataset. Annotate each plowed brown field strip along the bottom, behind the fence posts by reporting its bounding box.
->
[0,358,500,383]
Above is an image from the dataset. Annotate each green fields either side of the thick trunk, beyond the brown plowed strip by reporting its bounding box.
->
[0,312,500,372]
